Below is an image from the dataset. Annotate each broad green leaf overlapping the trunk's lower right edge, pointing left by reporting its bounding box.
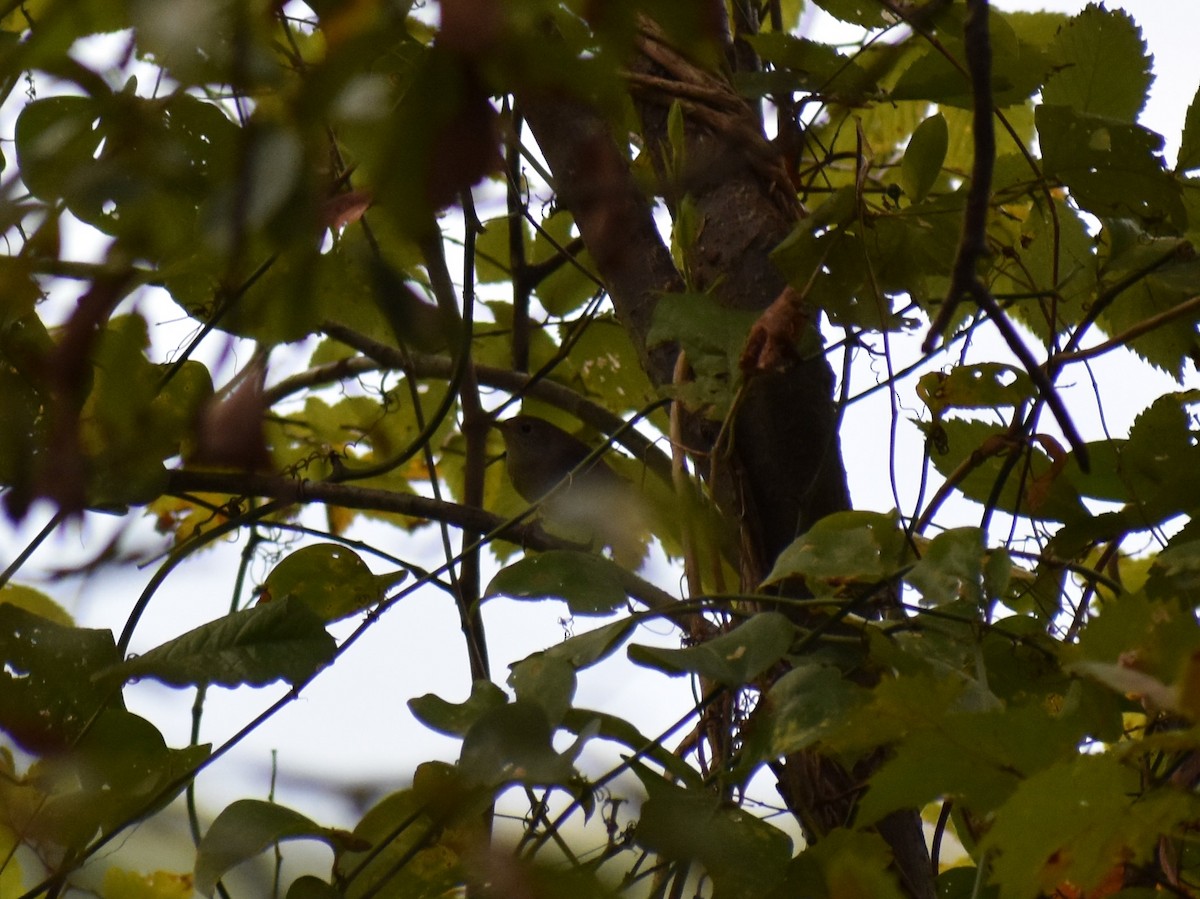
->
[763,511,908,597]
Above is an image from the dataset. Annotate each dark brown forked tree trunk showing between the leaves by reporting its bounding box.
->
[518,14,934,899]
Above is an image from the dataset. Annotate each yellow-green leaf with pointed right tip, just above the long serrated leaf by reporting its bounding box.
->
[259,544,408,623]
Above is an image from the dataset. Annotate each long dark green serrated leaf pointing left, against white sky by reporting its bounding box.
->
[112,598,336,687]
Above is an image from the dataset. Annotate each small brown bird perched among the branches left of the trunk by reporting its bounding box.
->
[496,415,646,564]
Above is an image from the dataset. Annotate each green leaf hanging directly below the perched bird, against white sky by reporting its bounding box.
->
[484,550,628,615]
